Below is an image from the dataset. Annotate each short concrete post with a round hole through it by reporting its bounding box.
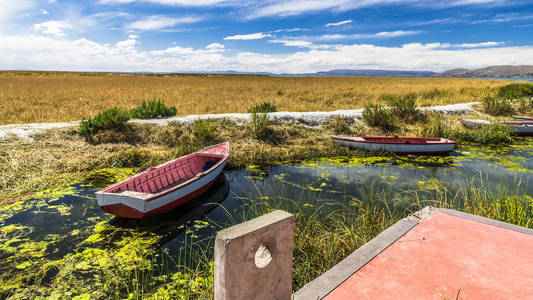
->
[215,210,294,300]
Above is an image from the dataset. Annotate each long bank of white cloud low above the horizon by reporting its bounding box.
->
[0,34,533,73]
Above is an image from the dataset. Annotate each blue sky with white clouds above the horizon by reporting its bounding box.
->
[0,0,533,73]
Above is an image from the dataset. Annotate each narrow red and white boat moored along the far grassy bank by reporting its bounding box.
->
[332,136,455,155]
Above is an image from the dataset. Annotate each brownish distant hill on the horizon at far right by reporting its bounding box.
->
[437,65,533,78]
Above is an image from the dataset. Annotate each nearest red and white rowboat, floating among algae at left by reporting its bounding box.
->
[96,142,229,218]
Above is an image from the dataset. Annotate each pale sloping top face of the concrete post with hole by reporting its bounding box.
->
[217,210,294,240]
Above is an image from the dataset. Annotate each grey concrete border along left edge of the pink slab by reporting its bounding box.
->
[294,217,420,300]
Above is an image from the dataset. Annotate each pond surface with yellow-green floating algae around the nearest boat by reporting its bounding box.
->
[0,139,533,299]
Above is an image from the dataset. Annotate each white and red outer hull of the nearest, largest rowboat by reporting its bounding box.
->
[96,161,226,219]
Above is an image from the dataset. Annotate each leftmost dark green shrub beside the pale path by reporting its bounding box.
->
[78,108,130,136]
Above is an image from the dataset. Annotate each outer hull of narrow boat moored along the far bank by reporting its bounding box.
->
[333,137,455,155]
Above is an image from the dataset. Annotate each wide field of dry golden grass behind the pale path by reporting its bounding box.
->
[0,71,507,125]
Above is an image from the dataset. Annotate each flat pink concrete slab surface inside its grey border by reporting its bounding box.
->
[326,212,533,300]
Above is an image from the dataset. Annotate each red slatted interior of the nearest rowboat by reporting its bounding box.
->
[104,153,224,194]
